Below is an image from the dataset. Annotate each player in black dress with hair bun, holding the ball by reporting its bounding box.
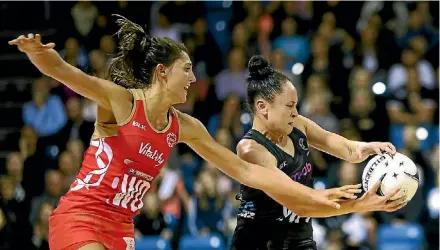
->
[230,56,406,250]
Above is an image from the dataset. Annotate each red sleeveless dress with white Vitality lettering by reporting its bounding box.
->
[49,90,179,250]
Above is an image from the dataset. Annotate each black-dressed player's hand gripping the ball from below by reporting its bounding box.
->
[356,181,407,212]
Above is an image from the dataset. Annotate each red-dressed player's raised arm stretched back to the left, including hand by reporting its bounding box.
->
[9,34,132,110]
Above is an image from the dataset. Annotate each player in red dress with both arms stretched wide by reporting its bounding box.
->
[9,18,360,250]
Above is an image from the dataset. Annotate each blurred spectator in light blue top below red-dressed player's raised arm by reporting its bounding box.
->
[23,77,67,137]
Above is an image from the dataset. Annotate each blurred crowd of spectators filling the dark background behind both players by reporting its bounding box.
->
[0,1,440,250]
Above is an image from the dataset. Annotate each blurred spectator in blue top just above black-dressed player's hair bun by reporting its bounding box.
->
[272,18,310,69]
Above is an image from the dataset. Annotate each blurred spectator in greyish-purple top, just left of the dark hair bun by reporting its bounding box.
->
[215,48,249,101]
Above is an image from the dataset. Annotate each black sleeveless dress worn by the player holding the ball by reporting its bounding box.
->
[230,128,316,250]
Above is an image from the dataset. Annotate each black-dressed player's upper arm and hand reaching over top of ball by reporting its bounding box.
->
[297,116,396,163]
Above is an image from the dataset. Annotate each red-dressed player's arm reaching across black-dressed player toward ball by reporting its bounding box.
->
[178,112,352,212]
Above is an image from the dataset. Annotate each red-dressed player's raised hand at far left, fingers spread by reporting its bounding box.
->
[8,33,55,54]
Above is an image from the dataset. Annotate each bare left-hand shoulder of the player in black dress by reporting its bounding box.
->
[237,139,276,168]
